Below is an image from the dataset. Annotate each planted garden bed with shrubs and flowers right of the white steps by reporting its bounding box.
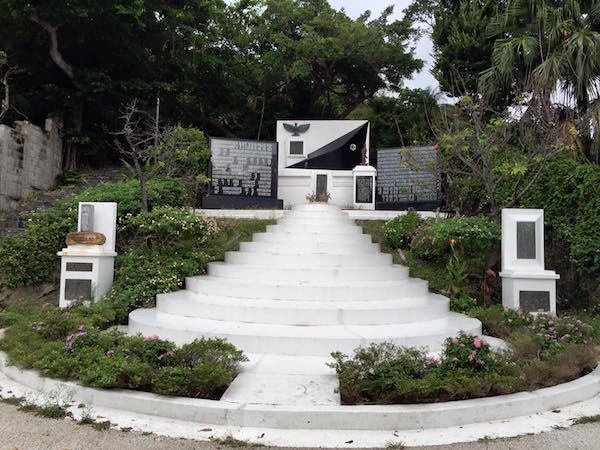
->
[346,211,600,404]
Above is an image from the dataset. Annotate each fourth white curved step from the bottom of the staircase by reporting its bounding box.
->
[208,262,408,283]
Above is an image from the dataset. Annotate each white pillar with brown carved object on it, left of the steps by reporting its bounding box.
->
[58,202,117,308]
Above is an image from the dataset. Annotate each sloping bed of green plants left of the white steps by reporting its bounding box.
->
[0,180,272,399]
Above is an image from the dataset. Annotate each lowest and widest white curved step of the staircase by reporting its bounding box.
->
[129,309,481,356]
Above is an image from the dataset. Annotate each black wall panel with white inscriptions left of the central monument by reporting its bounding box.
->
[210,138,277,197]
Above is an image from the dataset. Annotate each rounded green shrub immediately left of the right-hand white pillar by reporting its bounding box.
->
[411,216,500,268]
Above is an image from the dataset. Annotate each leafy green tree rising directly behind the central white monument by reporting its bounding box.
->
[227,0,422,133]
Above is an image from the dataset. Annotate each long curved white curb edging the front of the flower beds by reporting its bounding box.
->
[0,352,600,431]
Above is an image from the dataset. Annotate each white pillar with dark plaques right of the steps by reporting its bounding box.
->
[500,209,560,313]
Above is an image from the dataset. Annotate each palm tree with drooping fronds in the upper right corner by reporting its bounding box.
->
[481,0,600,158]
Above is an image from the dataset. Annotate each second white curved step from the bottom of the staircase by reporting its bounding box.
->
[156,290,448,325]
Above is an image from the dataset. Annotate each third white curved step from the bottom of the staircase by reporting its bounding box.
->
[185,275,428,302]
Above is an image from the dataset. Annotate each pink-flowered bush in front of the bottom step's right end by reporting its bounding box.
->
[442,332,495,371]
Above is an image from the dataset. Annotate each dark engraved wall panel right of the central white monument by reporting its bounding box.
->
[375,146,441,210]
